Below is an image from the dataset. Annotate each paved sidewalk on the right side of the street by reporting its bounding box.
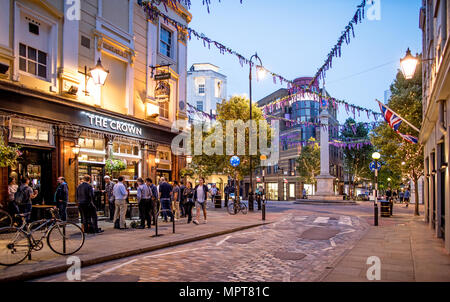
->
[320,205,450,282]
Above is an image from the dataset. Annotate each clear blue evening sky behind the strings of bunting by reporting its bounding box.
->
[188,0,422,121]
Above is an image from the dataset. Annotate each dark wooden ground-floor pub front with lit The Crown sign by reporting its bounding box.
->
[0,82,185,214]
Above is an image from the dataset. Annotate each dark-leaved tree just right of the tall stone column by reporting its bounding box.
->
[341,118,373,195]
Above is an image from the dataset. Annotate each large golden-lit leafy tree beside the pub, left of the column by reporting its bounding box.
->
[191,96,271,202]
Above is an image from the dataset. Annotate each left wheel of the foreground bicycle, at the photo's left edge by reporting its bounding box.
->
[0,227,31,266]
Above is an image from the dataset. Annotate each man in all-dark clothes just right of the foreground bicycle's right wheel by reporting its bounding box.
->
[76,175,103,233]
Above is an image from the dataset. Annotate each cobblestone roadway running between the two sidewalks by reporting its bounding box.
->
[36,206,369,282]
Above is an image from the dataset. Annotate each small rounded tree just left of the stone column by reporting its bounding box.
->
[297,138,320,185]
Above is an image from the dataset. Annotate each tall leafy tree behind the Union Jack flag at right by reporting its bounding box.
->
[372,64,423,216]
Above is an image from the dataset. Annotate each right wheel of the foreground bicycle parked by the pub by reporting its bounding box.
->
[47,222,84,255]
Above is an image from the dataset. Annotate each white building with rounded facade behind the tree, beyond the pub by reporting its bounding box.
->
[187,63,227,114]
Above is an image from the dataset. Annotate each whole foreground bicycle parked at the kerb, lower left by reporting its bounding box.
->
[0,209,85,266]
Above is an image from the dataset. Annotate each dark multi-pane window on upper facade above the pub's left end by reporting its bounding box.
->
[19,43,47,79]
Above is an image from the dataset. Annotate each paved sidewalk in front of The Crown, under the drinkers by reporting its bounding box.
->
[0,208,282,282]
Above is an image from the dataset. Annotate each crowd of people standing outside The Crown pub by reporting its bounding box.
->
[8,175,229,233]
